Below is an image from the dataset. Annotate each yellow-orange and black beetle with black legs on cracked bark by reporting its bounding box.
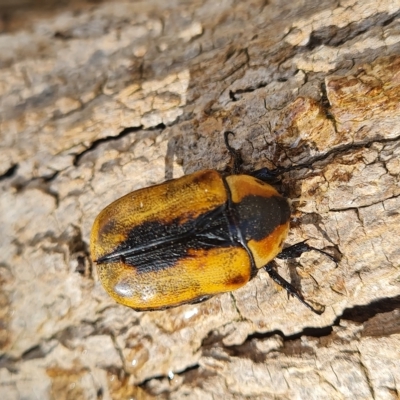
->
[90,131,332,314]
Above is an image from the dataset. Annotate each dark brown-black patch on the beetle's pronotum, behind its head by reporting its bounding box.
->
[235,195,290,241]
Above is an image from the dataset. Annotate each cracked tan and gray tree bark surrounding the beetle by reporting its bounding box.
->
[0,0,400,400]
